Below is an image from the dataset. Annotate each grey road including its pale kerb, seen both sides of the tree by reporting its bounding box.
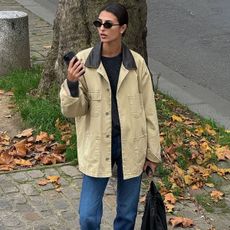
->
[14,0,230,129]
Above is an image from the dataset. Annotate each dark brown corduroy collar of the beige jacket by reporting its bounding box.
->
[85,43,137,70]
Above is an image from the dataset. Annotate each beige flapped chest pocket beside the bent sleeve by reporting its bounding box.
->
[89,91,101,117]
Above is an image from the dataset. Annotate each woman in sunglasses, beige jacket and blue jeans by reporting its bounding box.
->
[60,3,161,230]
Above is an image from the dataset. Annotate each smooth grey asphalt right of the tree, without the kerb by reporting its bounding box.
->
[147,0,230,101]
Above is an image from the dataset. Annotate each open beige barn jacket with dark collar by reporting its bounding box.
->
[60,44,161,179]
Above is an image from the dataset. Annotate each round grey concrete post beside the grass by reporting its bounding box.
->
[0,11,30,77]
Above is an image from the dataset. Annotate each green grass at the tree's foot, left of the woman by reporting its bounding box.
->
[0,65,76,161]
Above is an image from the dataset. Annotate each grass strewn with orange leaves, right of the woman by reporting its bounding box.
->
[153,92,230,227]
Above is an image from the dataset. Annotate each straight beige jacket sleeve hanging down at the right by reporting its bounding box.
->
[139,59,161,163]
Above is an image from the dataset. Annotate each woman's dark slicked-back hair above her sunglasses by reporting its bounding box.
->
[100,2,129,26]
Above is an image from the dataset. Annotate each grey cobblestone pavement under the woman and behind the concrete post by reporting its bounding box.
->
[0,0,230,230]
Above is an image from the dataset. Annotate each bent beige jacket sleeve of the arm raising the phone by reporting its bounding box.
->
[60,77,89,118]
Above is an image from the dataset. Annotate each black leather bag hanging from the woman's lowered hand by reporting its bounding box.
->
[141,181,167,230]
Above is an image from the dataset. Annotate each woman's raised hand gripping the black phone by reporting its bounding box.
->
[67,57,85,81]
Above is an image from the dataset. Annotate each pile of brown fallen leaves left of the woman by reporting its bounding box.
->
[0,129,66,171]
